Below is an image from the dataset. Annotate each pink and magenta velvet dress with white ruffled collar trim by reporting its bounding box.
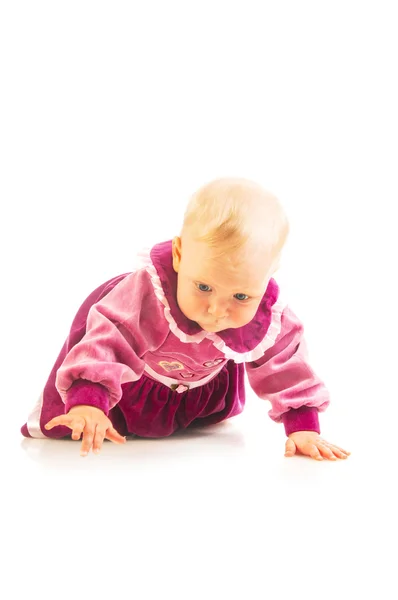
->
[21,241,329,438]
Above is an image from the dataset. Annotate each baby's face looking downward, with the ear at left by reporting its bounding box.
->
[173,238,276,333]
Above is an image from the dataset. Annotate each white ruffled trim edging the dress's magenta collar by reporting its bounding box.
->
[137,248,286,363]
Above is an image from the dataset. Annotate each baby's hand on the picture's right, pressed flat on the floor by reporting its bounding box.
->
[285,431,351,460]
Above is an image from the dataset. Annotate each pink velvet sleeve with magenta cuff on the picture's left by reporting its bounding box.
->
[56,270,168,414]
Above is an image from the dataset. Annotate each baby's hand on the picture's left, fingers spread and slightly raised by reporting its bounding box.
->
[45,404,126,456]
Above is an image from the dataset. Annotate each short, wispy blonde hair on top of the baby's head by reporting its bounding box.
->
[181,177,289,258]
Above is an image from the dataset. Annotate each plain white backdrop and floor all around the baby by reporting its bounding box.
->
[0,0,398,600]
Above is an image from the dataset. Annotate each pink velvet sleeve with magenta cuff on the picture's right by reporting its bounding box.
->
[246,307,330,435]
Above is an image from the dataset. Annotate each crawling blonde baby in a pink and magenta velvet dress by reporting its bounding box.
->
[21,178,350,460]
